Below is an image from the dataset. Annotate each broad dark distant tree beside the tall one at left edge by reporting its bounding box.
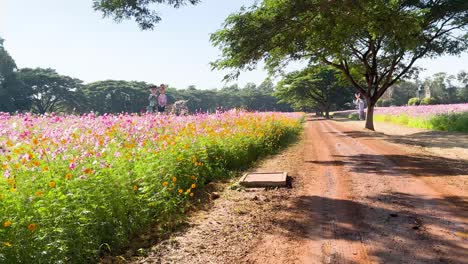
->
[19,68,82,114]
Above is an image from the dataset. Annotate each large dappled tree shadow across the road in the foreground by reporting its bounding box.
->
[273,193,468,263]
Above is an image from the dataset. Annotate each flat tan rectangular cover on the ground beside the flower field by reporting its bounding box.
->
[240,172,288,188]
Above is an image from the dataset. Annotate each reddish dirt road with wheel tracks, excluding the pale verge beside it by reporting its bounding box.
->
[245,120,468,263]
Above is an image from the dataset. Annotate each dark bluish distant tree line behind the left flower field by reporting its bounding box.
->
[0,36,293,114]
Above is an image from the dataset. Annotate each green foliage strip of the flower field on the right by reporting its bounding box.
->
[374,112,468,133]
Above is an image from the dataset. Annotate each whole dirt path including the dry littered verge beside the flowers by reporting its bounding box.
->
[125,120,468,263]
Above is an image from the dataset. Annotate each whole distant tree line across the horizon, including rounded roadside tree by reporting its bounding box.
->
[0,34,468,116]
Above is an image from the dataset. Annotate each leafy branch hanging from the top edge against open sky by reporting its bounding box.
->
[93,0,200,30]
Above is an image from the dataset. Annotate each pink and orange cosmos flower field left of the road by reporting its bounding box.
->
[0,111,303,263]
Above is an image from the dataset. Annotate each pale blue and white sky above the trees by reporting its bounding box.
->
[0,0,468,88]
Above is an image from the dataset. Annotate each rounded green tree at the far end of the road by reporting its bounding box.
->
[276,67,353,118]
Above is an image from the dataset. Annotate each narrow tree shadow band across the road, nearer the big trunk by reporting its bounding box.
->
[306,154,468,177]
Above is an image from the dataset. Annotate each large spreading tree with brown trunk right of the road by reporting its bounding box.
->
[211,0,468,130]
